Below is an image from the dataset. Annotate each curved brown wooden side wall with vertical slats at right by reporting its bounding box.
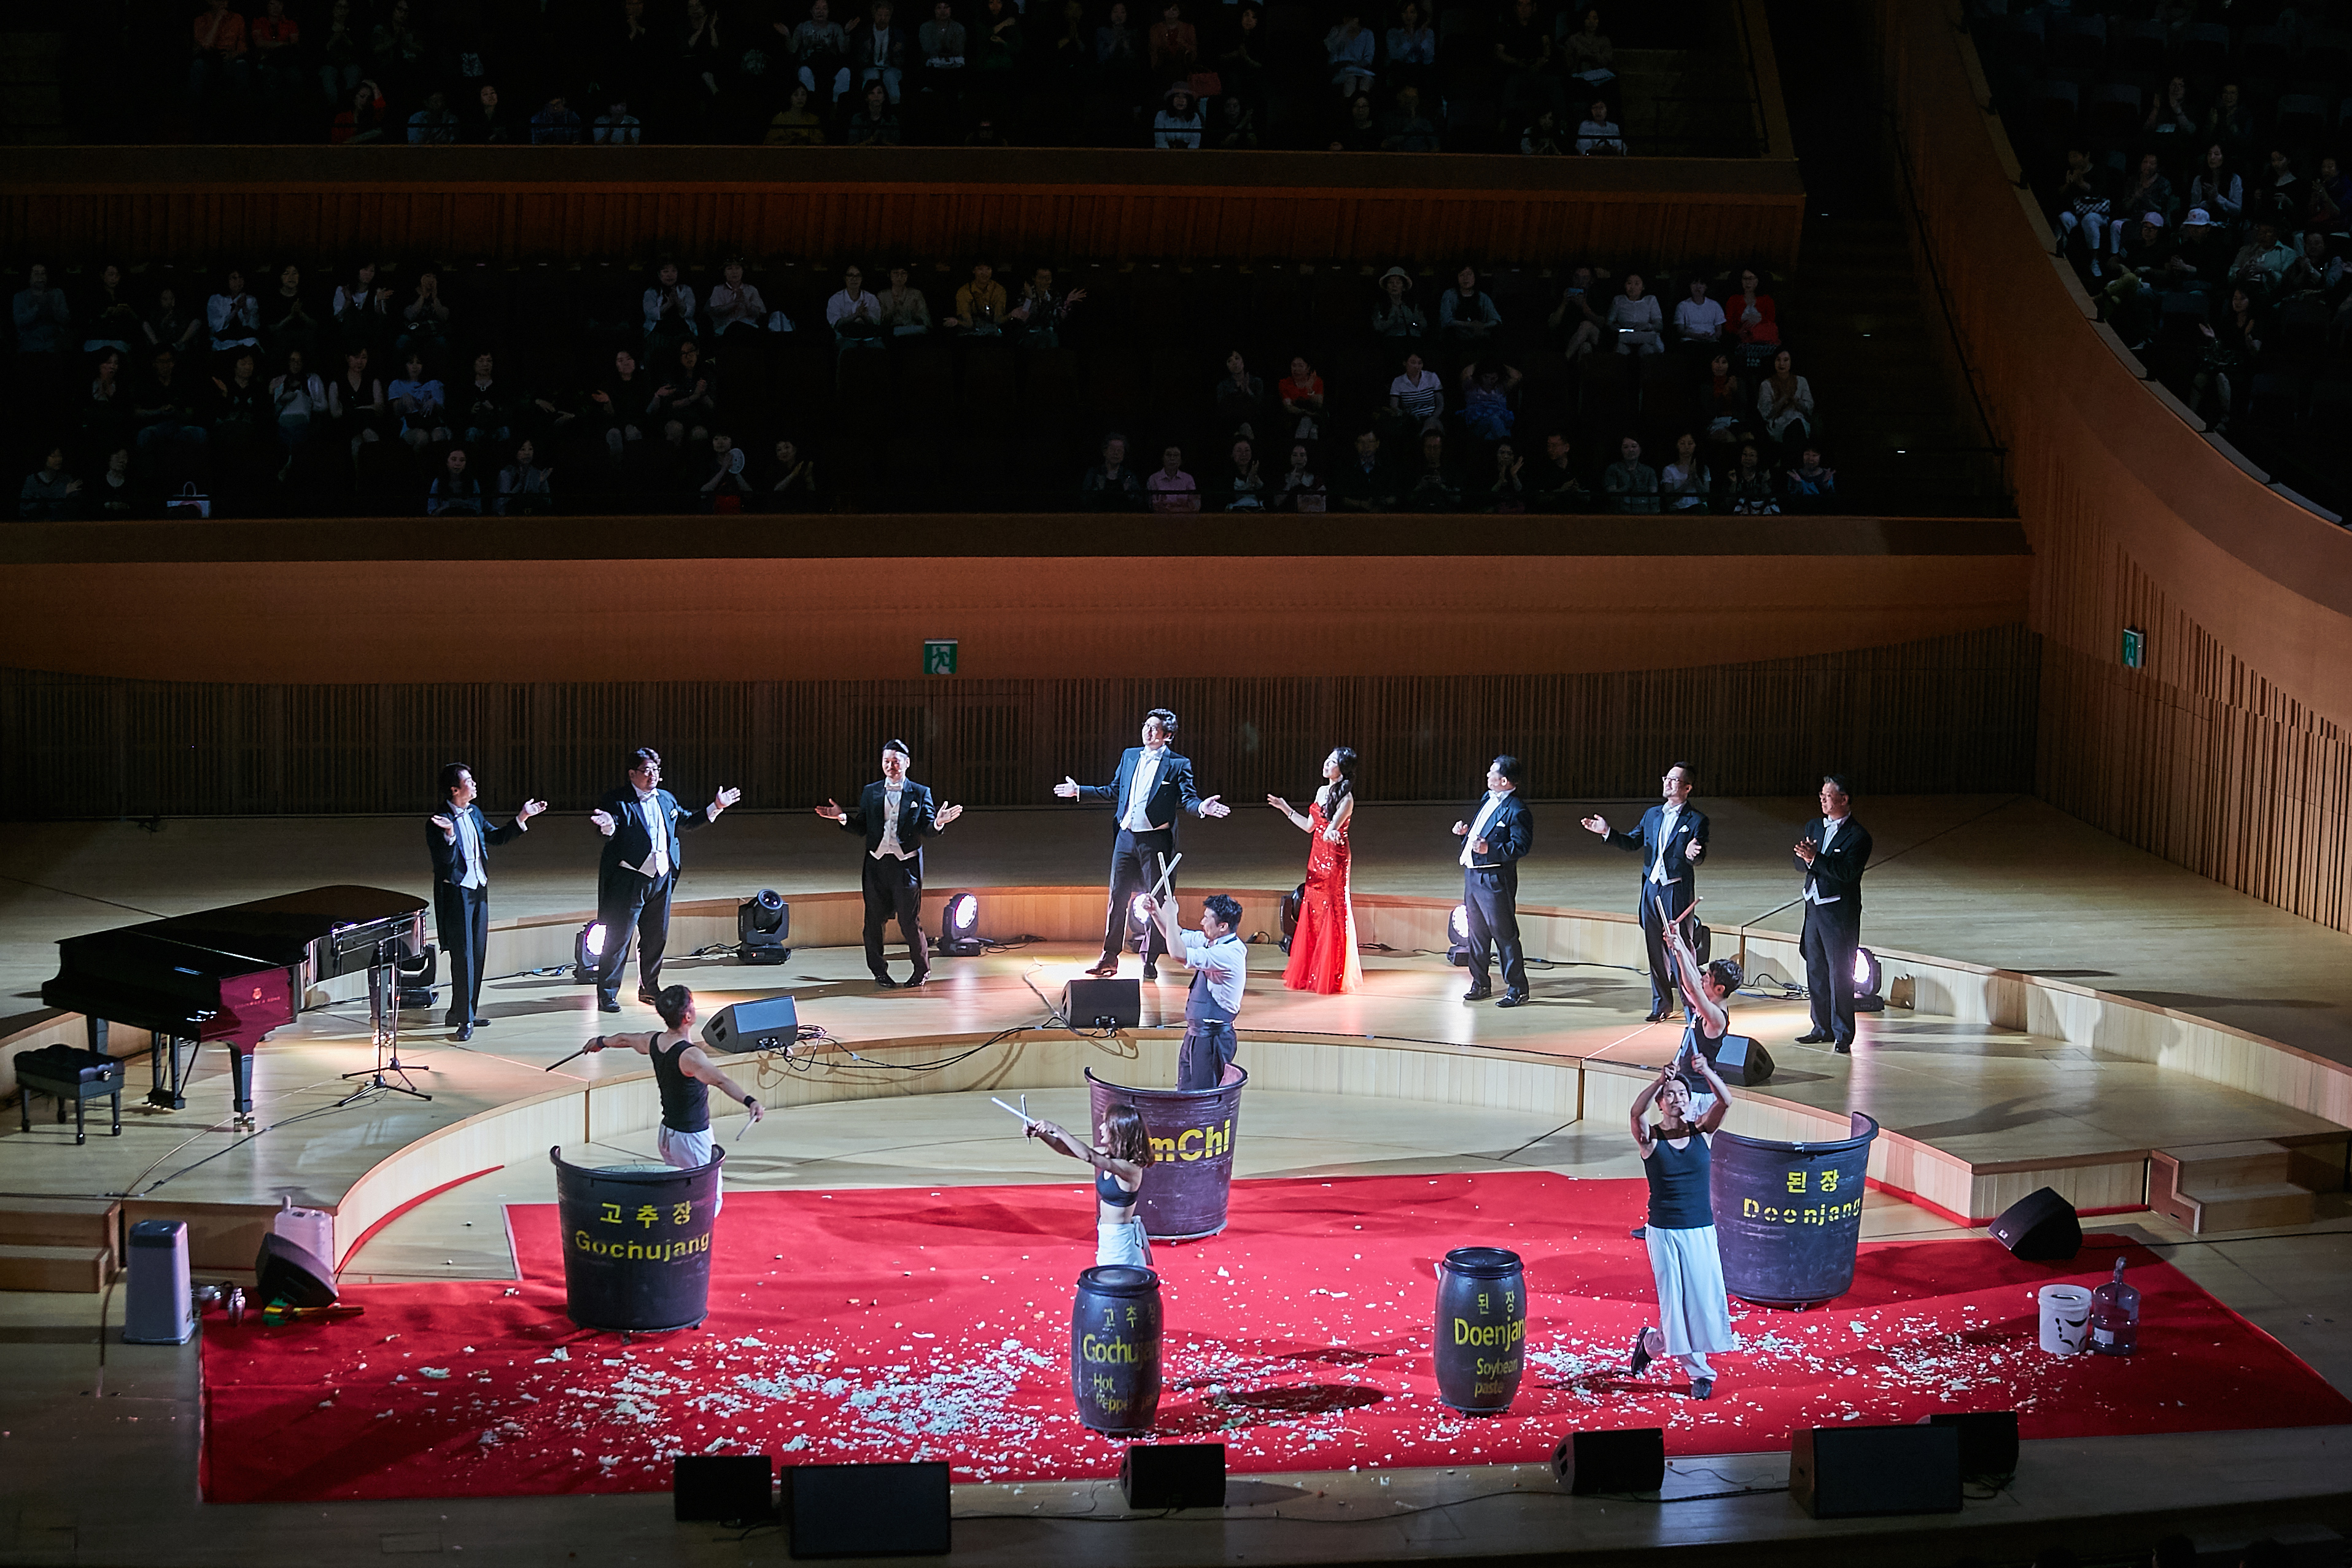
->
[1877,0,2352,931]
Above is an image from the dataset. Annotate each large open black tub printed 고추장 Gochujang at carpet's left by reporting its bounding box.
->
[548,1149,727,1333]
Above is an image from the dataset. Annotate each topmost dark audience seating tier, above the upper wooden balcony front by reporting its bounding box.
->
[54,0,1761,158]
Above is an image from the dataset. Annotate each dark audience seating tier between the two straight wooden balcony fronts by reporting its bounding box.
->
[7,256,1863,517]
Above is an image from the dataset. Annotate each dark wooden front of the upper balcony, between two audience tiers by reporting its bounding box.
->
[0,148,1804,268]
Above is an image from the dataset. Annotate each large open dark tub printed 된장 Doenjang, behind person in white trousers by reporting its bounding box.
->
[1707,1112,1879,1307]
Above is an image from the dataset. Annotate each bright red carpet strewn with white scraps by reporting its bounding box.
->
[204,1173,2352,1502]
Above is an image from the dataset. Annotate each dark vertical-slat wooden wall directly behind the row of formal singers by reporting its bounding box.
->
[0,626,2039,816]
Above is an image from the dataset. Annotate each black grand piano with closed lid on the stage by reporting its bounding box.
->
[40,887,425,1121]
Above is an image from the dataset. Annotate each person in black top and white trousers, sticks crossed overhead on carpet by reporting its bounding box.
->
[1632,1034,1738,1399]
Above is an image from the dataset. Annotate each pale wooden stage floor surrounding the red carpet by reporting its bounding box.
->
[0,797,2352,1568]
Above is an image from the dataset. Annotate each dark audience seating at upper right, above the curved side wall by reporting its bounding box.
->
[1973,0,2352,515]
